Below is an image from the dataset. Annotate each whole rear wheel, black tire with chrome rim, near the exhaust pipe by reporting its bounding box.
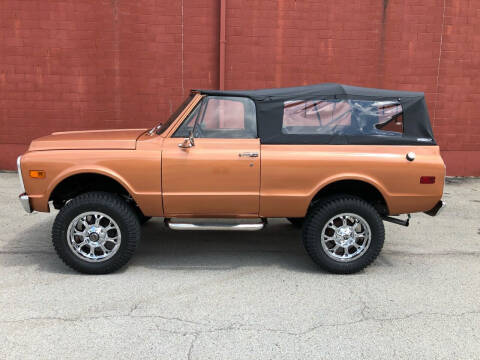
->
[303,195,385,274]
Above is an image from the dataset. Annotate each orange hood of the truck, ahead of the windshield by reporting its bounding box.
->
[29,129,147,151]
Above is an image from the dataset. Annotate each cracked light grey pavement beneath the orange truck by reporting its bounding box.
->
[0,173,480,360]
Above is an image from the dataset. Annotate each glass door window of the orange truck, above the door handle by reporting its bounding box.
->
[173,96,257,139]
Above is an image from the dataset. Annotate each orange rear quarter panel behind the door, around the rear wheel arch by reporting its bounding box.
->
[260,145,445,217]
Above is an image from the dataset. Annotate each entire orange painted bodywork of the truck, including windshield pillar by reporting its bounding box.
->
[21,94,445,217]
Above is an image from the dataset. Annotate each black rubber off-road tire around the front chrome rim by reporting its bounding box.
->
[52,192,141,274]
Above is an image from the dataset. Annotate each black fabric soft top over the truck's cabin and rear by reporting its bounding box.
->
[194,83,436,145]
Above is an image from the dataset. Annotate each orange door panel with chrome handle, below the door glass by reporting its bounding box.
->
[162,138,260,217]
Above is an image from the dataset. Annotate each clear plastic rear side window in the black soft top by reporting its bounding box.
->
[282,99,403,136]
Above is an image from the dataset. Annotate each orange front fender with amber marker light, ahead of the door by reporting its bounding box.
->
[21,136,164,216]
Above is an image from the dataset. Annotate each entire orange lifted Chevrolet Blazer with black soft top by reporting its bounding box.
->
[17,84,445,274]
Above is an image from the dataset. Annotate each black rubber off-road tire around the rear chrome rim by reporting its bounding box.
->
[303,195,385,274]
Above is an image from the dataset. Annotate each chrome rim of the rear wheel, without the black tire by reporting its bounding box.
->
[321,213,371,262]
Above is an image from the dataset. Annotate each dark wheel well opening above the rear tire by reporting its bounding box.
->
[312,180,388,215]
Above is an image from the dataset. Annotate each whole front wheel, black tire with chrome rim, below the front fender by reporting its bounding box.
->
[52,192,141,274]
